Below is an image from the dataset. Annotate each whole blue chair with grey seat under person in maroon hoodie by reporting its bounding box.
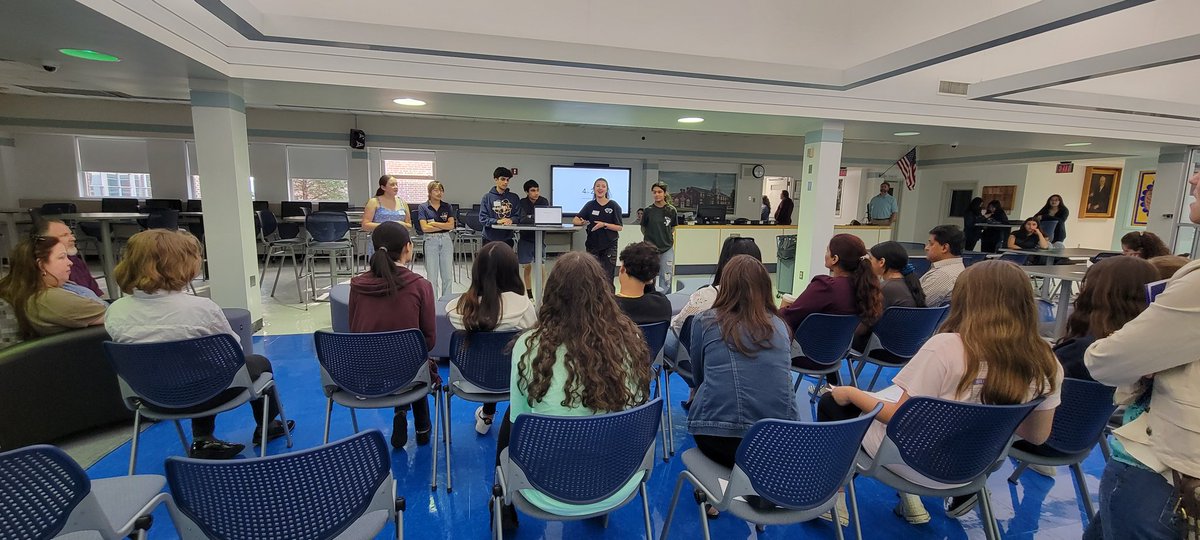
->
[312,329,437,443]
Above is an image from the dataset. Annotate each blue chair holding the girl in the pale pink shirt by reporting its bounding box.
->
[857,397,1042,540]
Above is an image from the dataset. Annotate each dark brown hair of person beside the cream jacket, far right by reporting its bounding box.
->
[1063,257,1158,340]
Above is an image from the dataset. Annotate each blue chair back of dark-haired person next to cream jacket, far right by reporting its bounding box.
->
[1045,379,1117,454]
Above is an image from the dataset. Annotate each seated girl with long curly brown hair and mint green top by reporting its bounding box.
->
[496,251,650,529]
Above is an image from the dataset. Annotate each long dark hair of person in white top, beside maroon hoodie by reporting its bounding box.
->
[457,242,524,332]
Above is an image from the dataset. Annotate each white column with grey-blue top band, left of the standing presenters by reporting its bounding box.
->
[191,79,263,326]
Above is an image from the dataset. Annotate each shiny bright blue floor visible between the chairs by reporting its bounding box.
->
[88,335,1104,540]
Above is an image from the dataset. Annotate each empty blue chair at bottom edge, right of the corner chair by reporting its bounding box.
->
[167,430,404,540]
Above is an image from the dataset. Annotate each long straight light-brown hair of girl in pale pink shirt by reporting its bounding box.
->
[940,260,1058,404]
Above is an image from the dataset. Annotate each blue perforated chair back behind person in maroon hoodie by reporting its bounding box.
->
[312,329,430,397]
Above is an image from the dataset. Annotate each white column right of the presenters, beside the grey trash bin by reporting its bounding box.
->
[792,121,845,294]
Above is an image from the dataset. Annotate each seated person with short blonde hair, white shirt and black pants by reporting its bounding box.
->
[104,229,295,460]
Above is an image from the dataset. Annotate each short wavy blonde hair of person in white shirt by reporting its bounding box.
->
[113,229,200,294]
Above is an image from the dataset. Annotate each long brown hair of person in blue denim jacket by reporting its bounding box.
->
[713,254,779,356]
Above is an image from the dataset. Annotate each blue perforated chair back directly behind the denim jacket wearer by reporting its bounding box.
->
[734,404,883,510]
